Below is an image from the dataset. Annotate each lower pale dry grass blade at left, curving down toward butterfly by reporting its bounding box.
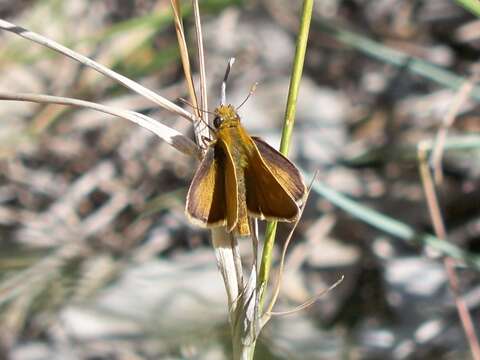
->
[0,92,200,157]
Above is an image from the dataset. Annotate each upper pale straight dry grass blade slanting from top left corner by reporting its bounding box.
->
[0,19,195,122]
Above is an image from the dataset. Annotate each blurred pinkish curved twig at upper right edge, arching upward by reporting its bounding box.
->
[430,71,480,184]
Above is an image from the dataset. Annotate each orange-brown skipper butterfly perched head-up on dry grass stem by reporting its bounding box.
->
[186,61,306,236]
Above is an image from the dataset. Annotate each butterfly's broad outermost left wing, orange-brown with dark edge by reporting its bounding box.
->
[185,144,227,227]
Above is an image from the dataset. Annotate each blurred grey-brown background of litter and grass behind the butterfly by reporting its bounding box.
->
[0,0,480,360]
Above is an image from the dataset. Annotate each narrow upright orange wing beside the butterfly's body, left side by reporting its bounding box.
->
[216,138,238,232]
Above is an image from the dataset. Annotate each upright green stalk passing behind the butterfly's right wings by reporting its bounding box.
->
[258,0,313,309]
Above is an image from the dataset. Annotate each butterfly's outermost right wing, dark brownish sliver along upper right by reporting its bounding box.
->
[252,136,306,205]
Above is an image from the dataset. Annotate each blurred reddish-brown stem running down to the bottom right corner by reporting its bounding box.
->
[418,142,480,360]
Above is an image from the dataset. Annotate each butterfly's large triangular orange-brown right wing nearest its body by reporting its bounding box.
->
[245,140,299,221]
